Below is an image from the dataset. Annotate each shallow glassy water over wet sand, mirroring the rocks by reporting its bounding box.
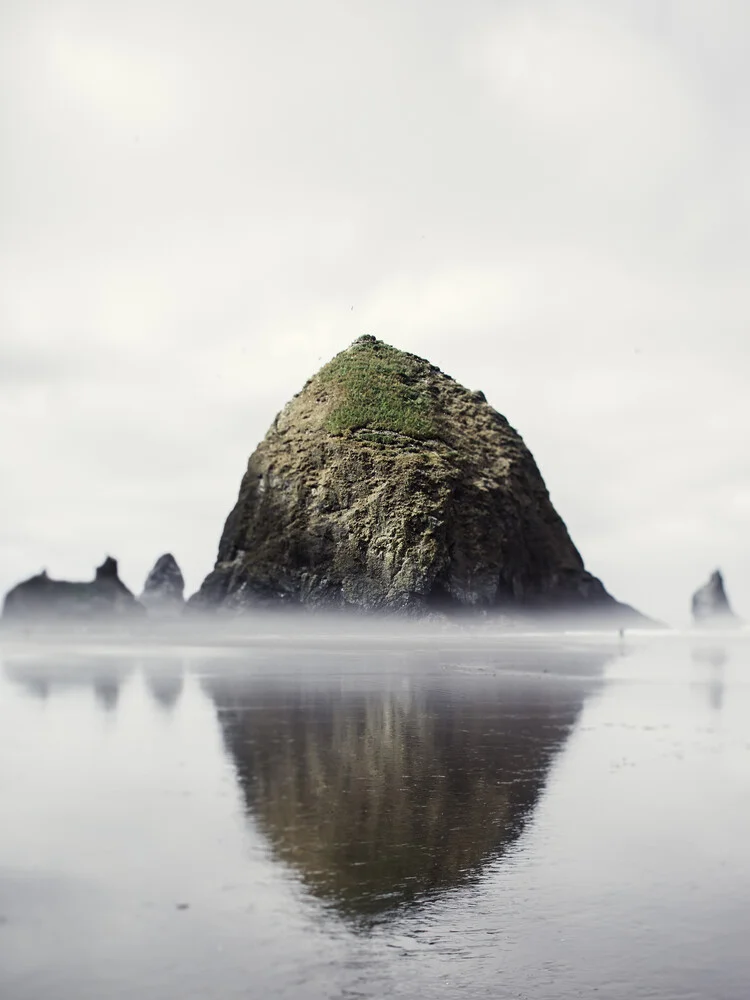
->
[0,633,750,1000]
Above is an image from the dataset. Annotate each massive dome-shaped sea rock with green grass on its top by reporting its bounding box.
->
[190,336,648,625]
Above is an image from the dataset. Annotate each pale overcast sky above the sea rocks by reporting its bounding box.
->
[0,0,750,623]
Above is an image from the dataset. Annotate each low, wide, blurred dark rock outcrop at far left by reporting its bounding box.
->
[3,556,145,622]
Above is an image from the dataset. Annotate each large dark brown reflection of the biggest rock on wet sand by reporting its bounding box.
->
[206,648,604,915]
